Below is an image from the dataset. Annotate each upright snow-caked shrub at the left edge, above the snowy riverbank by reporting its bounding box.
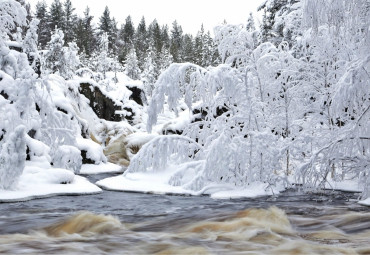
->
[0,126,26,189]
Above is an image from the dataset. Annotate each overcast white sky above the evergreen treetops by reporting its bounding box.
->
[26,0,263,34]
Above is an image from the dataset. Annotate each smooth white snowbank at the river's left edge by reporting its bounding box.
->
[0,162,102,202]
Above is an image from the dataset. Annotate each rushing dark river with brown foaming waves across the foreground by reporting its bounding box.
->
[0,174,370,254]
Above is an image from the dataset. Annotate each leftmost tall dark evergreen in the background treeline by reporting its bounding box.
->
[35,0,51,49]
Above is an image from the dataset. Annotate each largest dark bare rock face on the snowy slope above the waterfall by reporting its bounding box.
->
[80,83,122,121]
